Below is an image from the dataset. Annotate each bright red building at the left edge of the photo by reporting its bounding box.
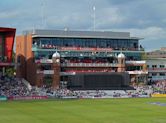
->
[0,27,16,74]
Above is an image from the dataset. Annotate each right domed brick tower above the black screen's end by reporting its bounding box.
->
[118,53,126,72]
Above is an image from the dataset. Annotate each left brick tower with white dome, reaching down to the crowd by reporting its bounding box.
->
[52,52,60,89]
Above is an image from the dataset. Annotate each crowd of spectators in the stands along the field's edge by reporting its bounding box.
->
[0,76,166,98]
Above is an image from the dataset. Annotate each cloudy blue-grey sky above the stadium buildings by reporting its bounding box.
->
[0,0,166,51]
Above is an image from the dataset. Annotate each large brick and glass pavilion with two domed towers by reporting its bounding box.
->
[16,30,147,88]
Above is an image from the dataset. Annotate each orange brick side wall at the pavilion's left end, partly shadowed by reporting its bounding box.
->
[16,35,36,85]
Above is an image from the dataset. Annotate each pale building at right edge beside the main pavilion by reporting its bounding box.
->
[147,47,166,82]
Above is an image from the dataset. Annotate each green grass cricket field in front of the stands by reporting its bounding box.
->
[0,98,166,123]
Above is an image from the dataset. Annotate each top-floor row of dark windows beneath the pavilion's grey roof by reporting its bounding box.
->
[33,38,139,49]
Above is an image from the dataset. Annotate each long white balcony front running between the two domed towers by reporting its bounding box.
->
[61,63,117,67]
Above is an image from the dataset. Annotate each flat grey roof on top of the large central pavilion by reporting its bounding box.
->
[24,29,141,39]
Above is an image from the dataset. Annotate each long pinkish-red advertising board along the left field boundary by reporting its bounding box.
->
[8,96,48,100]
